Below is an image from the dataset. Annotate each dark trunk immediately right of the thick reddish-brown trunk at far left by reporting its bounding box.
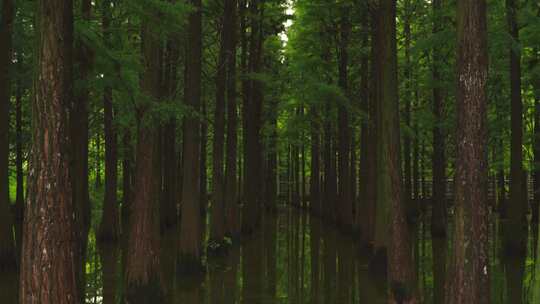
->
[71,0,93,300]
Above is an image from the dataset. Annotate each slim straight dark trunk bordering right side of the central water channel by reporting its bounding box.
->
[338,6,353,231]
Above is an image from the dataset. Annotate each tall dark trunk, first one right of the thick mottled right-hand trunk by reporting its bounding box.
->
[505,0,528,254]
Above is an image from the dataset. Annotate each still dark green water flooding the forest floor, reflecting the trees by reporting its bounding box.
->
[0,207,540,304]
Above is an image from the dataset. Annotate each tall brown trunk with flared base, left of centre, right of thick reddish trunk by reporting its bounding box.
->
[178,0,202,273]
